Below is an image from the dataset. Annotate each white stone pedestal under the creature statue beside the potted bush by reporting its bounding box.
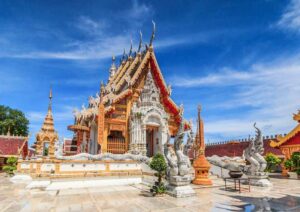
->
[167,175,196,198]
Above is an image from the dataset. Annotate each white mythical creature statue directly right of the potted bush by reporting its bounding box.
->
[164,120,191,177]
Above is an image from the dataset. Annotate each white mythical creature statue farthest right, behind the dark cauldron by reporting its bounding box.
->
[243,123,267,175]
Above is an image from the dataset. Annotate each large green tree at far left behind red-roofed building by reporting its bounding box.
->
[0,105,29,136]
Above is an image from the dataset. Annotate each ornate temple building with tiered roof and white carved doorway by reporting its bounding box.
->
[68,29,183,157]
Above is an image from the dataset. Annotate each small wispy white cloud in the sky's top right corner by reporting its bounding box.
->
[277,0,300,33]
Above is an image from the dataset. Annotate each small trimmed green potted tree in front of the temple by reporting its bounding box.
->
[150,153,167,196]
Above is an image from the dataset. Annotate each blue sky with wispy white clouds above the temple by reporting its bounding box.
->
[0,0,300,142]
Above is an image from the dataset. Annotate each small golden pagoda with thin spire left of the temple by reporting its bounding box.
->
[35,88,58,158]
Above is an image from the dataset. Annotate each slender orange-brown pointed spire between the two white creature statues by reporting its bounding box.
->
[193,105,212,185]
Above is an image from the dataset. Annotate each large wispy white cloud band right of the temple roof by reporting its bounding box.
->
[173,53,300,138]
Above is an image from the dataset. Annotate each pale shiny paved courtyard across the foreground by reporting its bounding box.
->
[0,175,300,212]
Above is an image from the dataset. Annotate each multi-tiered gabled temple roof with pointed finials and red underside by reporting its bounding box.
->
[69,23,181,130]
